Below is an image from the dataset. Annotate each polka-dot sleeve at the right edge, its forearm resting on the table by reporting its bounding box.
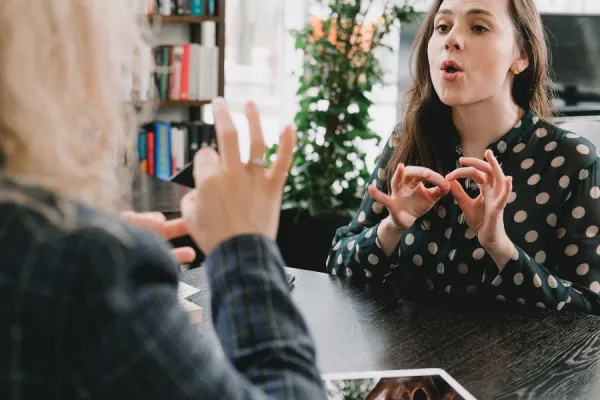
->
[496,160,600,314]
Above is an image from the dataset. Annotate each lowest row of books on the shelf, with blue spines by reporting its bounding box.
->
[137,121,217,180]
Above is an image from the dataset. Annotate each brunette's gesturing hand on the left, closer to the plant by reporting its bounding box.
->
[368,164,450,230]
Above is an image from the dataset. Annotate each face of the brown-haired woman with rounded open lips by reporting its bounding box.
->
[427,0,528,106]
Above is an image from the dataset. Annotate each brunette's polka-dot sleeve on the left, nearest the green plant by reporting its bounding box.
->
[326,137,399,283]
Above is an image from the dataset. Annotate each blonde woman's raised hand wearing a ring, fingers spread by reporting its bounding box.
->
[181,99,296,254]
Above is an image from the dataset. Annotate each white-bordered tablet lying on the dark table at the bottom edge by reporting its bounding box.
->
[322,368,475,400]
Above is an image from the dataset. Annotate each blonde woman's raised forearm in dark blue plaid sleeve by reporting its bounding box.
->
[205,236,324,398]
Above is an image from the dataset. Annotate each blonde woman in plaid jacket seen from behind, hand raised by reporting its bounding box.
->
[0,0,325,400]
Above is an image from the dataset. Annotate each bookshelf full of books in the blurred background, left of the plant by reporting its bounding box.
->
[135,0,226,184]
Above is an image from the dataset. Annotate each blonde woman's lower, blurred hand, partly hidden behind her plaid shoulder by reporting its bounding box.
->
[121,211,196,264]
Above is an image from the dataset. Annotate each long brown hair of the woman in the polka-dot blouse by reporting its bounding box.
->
[385,0,551,188]
